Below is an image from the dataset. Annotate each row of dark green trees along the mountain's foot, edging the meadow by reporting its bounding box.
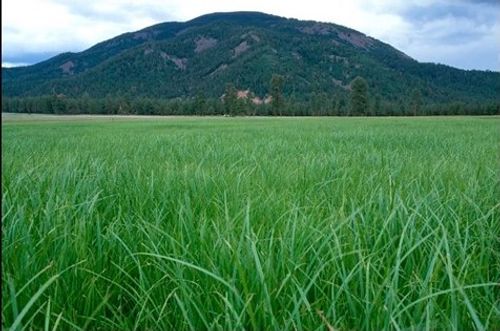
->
[2,75,500,116]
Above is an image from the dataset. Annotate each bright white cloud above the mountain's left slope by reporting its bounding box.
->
[2,0,166,56]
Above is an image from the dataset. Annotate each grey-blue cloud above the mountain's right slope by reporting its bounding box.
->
[394,0,500,71]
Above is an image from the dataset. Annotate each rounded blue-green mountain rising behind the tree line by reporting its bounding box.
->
[2,12,500,102]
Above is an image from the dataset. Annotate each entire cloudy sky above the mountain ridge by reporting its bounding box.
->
[2,0,500,71]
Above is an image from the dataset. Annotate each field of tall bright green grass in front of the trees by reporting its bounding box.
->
[2,116,500,331]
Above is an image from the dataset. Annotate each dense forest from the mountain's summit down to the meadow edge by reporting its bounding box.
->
[2,12,500,115]
